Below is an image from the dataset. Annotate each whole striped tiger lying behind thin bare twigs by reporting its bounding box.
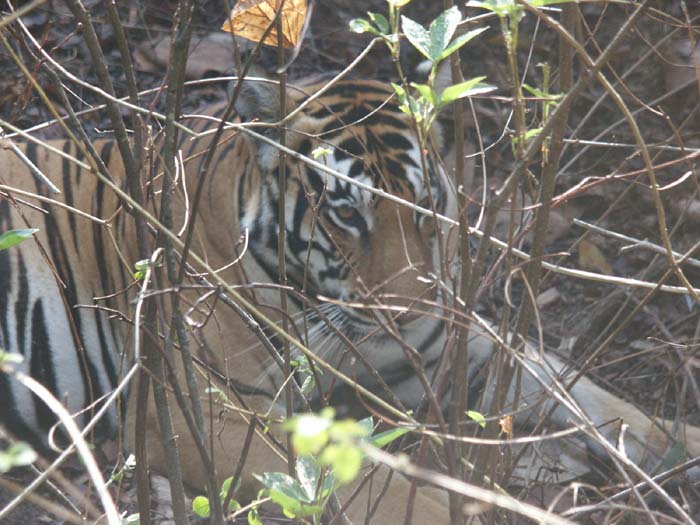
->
[0,81,700,523]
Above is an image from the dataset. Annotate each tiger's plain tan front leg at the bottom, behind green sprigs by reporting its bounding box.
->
[127,328,450,525]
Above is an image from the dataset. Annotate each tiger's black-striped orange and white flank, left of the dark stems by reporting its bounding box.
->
[0,140,133,442]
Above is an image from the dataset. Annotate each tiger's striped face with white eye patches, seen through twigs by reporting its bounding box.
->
[241,77,454,398]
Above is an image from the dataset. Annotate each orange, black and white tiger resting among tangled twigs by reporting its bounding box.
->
[0,75,700,524]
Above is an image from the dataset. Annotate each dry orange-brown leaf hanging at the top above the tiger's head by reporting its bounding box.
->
[221,0,306,48]
